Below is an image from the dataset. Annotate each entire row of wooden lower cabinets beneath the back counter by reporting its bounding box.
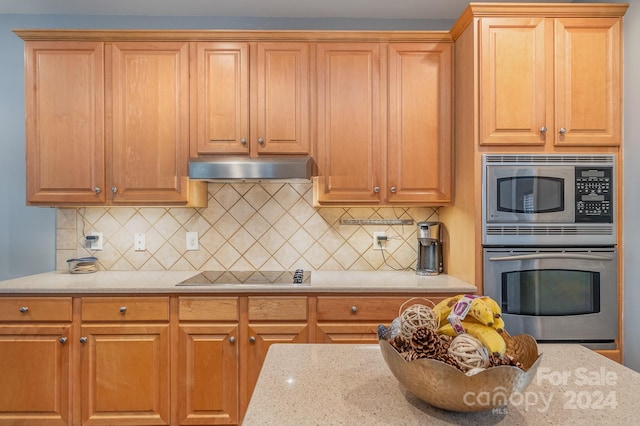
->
[0,294,450,426]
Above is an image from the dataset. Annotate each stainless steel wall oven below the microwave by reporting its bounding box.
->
[484,247,618,349]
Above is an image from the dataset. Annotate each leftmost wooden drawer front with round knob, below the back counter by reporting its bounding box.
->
[0,297,73,322]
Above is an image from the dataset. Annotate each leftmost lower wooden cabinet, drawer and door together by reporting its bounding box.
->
[0,297,72,426]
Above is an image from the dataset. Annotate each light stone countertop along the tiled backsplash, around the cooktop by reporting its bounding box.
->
[0,271,476,294]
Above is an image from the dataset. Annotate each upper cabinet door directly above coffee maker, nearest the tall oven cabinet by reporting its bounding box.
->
[386,43,453,203]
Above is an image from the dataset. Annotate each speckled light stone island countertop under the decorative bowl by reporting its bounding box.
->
[242,344,640,426]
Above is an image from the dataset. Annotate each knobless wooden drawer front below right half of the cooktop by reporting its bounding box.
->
[248,296,307,321]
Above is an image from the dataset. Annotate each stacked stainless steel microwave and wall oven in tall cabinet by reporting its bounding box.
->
[482,154,618,349]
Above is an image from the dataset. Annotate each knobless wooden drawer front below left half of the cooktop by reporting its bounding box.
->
[178,297,238,321]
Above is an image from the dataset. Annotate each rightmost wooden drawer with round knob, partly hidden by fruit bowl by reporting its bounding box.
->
[318,296,409,322]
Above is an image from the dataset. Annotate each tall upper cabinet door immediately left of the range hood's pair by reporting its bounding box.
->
[110,42,189,203]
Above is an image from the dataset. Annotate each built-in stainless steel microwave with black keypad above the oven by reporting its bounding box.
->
[482,154,616,246]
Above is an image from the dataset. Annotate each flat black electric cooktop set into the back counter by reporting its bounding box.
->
[178,269,311,286]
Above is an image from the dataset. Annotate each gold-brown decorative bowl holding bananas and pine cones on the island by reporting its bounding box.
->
[378,326,542,412]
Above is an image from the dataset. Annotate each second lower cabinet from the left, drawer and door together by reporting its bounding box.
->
[79,297,171,426]
